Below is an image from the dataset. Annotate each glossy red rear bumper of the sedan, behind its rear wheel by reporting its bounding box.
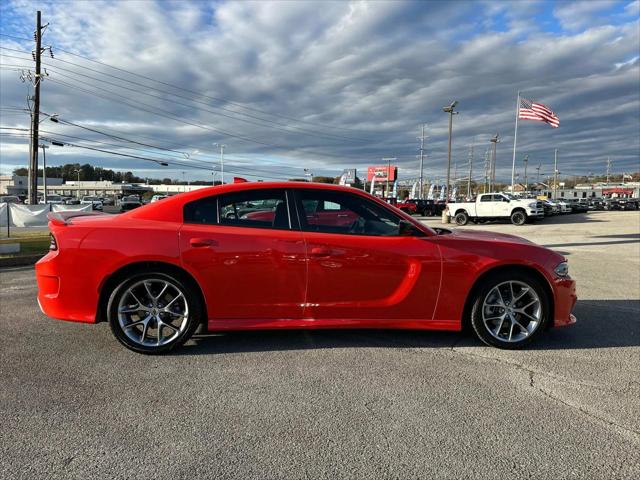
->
[36,252,98,323]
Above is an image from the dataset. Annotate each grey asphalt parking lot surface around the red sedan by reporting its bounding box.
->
[0,212,640,479]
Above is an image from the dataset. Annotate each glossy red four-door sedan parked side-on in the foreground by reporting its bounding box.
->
[36,182,576,353]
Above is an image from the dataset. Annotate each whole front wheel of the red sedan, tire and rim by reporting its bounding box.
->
[471,271,551,349]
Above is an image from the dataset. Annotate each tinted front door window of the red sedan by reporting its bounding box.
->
[298,190,400,236]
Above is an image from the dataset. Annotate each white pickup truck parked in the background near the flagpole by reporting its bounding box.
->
[447,193,544,225]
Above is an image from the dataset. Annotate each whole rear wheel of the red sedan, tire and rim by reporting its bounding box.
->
[107,272,201,354]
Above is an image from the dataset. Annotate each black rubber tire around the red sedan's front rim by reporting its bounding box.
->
[470,270,551,350]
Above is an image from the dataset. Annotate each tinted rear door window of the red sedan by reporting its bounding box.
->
[218,190,290,229]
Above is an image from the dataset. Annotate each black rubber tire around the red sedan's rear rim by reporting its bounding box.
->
[107,271,202,354]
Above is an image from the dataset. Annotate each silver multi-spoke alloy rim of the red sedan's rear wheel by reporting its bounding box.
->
[117,279,189,347]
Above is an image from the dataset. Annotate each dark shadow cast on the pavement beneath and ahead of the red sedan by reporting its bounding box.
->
[173,300,640,355]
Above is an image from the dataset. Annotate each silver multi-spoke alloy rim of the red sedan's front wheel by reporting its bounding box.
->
[482,281,543,343]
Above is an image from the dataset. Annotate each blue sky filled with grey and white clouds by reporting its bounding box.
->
[0,0,640,184]
